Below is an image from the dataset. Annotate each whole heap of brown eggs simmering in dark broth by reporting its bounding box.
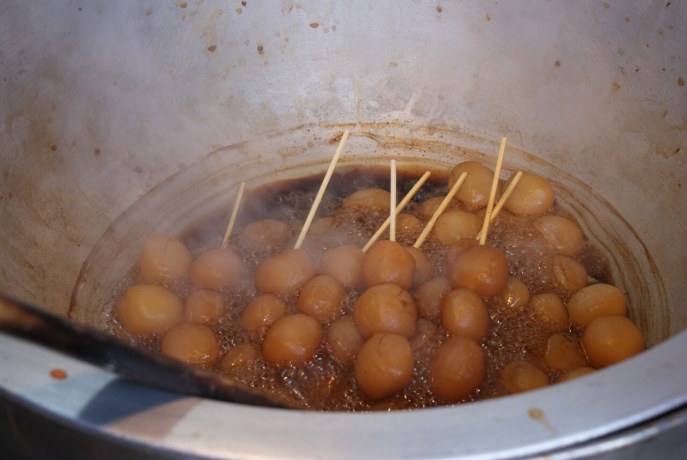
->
[114,161,645,408]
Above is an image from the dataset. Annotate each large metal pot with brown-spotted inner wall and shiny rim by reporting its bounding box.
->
[0,0,687,458]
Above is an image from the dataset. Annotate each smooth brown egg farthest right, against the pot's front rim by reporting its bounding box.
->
[582,315,645,368]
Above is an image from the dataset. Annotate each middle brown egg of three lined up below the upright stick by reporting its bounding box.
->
[353,283,417,338]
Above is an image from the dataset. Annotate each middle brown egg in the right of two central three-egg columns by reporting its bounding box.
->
[441,289,489,342]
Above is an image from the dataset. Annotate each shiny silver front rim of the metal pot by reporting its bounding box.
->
[0,332,687,458]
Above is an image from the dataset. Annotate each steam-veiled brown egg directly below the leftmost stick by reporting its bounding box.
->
[190,248,244,291]
